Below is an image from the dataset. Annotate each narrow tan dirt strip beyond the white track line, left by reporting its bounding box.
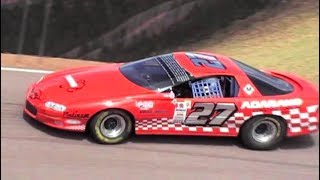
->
[1,53,104,71]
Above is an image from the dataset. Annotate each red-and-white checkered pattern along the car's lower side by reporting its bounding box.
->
[135,105,319,136]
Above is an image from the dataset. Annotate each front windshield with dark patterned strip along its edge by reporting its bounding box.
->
[120,54,190,92]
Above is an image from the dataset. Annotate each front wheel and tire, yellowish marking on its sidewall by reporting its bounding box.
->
[89,110,133,144]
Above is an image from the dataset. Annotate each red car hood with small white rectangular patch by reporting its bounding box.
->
[35,63,153,104]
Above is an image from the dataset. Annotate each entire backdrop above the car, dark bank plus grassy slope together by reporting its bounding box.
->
[1,0,319,83]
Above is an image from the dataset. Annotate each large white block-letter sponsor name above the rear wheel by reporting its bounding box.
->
[241,98,303,109]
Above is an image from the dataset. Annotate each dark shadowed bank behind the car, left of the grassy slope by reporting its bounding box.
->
[1,0,278,61]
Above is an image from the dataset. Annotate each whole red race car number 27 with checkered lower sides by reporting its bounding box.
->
[24,52,319,150]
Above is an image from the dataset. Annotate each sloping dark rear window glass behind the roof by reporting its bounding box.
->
[234,60,293,96]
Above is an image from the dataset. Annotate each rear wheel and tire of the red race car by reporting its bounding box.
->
[240,116,287,150]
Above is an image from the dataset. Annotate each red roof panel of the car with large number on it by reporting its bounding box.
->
[173,52,245,77]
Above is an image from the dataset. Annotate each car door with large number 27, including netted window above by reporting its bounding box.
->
[172,76,240,126]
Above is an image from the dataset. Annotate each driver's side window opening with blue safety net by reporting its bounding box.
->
[172,76,239,98]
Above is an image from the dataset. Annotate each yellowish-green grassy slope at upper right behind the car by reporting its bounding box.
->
[178,0,319,84]
